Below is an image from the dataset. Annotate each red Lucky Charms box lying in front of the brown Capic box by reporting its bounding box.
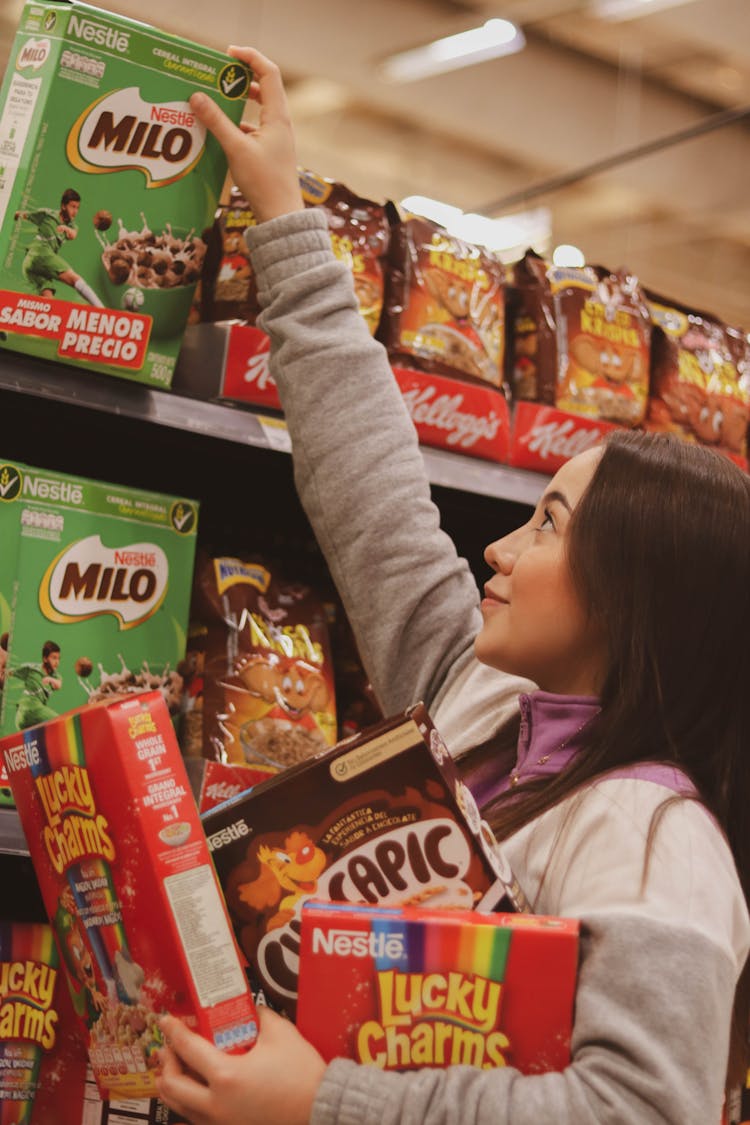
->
[297,902,579,1074]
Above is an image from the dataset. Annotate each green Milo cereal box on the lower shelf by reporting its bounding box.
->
[0,459,198,798]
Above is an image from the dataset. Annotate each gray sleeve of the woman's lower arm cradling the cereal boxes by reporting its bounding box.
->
[310,915,735,1125]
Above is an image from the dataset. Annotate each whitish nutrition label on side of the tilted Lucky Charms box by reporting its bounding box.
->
[164,866,247,1008]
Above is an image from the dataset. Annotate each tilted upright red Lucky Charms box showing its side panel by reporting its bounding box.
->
[0,692,257,1098]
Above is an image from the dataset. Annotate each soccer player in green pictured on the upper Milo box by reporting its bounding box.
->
[16,188,103,308]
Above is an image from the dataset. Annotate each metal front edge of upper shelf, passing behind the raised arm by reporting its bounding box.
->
[0,351,546,505]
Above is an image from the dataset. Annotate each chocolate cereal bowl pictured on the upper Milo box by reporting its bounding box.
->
[99,215,206,339]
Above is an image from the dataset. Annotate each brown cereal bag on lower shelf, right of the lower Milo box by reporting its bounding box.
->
[183,556,336,772]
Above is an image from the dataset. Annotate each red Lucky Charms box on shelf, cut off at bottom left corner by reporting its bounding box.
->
[0,921,87,1125]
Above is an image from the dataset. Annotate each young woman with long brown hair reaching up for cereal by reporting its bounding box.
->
[155,48,750,1125]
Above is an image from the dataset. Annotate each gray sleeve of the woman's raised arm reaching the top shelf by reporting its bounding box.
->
[247,209,481,713]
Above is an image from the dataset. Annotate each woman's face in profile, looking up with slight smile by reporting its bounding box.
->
[475,449,606,695]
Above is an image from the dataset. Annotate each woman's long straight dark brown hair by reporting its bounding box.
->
[474,431,750,1079]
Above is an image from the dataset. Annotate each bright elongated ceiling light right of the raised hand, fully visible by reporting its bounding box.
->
[380,19,526,82]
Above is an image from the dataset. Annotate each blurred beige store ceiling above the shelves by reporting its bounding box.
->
[0,0,750,330]
